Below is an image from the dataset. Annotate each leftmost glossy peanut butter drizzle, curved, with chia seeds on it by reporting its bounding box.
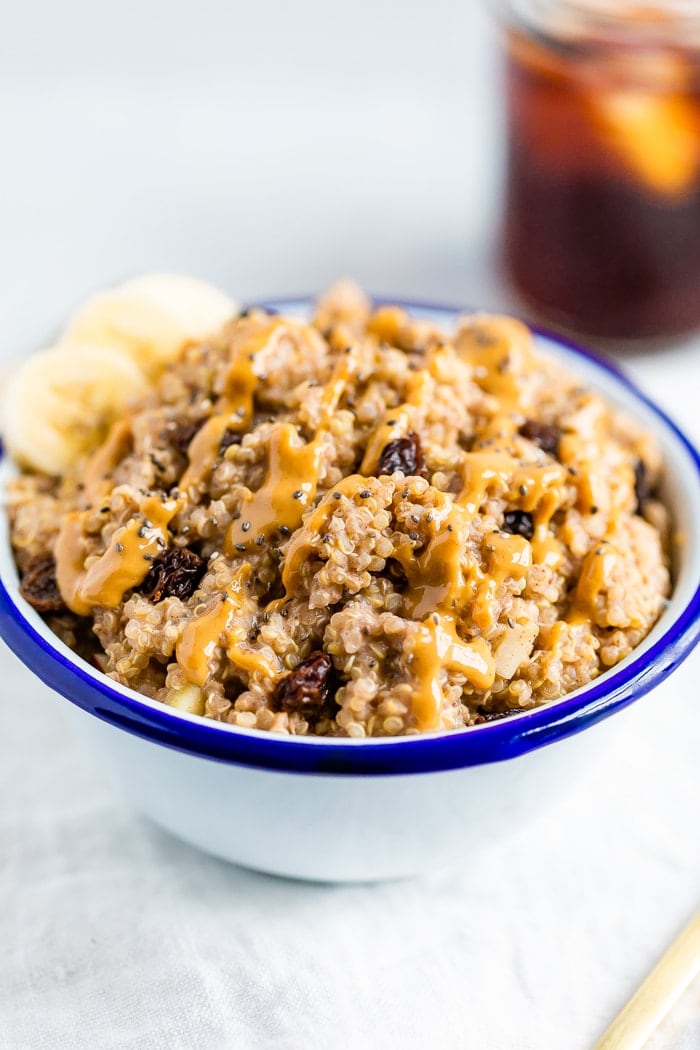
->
[55,497,179,616]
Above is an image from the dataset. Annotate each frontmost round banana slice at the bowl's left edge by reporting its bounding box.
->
[3,345,148,475]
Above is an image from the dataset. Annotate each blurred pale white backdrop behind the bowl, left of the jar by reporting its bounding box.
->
[0,0,500,352]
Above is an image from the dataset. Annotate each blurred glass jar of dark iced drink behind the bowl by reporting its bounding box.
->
[505,0,700,339]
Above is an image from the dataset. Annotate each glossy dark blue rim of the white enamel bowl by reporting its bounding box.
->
[0,295,700,776]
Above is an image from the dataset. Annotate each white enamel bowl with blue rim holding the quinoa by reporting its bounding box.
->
[0,299,700,881]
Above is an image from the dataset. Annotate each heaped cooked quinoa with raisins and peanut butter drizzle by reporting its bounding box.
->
[10,282,670,737]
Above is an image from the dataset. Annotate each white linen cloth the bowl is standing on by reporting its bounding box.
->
[0,653,700,1050]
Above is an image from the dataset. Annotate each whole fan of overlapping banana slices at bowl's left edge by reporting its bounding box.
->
[2,273,237,475]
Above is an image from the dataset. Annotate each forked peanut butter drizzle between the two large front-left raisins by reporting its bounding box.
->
[175,565,279,687]
